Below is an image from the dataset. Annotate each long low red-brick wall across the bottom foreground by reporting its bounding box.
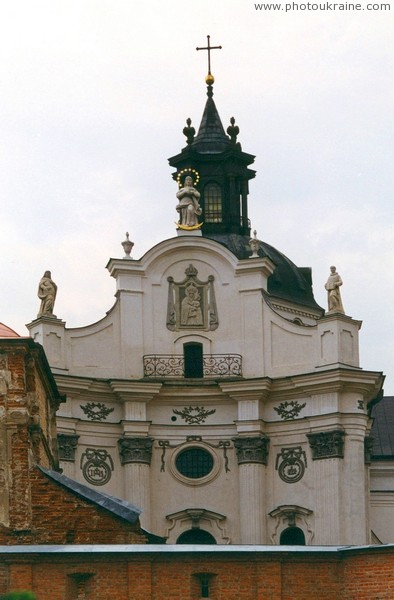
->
[0,546,394,600]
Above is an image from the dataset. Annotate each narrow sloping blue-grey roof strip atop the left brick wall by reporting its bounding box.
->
[38,465,142,523]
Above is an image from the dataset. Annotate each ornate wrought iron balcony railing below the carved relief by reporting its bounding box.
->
[143,354,242,379]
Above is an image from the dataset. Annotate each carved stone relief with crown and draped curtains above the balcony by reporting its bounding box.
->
[167,265,219,331]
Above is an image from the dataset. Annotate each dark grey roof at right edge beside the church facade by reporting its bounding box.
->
[371,396,394,460]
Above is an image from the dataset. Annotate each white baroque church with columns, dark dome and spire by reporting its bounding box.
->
[28,76,384,546]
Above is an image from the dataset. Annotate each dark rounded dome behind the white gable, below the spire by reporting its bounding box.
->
[204,233,324,314]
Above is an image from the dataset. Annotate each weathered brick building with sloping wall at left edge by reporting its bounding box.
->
[0,338,146,545]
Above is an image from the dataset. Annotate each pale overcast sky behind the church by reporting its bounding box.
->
[0,0,394,394]
